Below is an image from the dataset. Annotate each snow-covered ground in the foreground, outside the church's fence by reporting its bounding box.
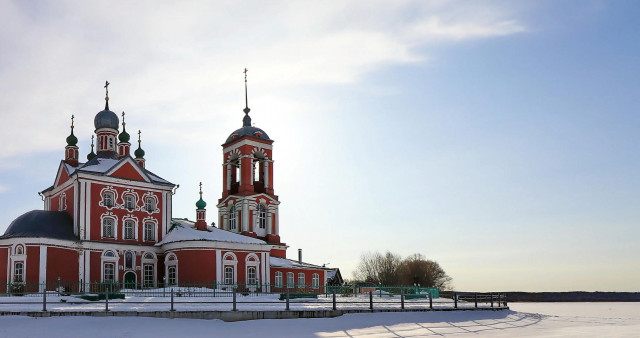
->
[0,303,640,337]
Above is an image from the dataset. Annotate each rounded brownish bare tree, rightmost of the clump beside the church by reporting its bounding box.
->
[398,254,451,289]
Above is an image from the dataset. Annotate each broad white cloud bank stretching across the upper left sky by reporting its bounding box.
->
[0,1,524,158]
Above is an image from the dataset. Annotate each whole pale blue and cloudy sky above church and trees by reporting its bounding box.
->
[0,1,640,291]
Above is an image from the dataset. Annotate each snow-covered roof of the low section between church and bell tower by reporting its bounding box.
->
[156,218,267,246]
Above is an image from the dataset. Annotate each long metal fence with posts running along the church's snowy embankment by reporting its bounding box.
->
[0,282,507,312]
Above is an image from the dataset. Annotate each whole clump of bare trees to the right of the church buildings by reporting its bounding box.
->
[354,251,451,290]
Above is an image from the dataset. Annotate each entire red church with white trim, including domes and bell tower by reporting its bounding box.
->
[0,78,334,292]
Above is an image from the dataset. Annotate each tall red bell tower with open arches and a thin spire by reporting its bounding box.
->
[217,68,286,250]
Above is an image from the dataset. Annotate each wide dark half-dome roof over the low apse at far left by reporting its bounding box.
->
[0,210,78,241]
